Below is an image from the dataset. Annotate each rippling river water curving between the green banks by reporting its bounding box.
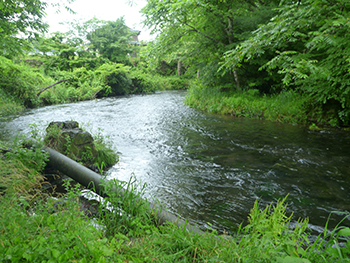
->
[0,91,350,232]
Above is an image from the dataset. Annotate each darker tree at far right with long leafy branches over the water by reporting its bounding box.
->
[224,0,350,123]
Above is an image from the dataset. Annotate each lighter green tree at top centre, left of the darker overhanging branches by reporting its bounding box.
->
[142,0,277,89]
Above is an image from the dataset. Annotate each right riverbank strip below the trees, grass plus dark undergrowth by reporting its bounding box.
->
[185,84,349,130]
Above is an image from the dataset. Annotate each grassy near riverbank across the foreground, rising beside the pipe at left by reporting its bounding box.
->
[0,129,350,262]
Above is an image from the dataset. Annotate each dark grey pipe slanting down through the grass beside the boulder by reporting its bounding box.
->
[43,146,203,234]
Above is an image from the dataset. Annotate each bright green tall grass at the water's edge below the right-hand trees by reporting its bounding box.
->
[185,84,308,124]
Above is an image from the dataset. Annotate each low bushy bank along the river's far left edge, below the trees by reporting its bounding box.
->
[0,56,191,117]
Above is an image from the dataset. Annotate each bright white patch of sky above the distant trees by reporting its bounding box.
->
[44,0,153,40]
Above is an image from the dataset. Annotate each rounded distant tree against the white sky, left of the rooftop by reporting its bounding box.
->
[87,18,135,63]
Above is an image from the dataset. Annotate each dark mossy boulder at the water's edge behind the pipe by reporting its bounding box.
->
[45,121,97,165]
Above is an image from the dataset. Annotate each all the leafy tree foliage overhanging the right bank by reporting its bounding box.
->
[142,0,350,126]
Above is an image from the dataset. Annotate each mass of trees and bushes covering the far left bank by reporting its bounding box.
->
[0,1,187,115]
